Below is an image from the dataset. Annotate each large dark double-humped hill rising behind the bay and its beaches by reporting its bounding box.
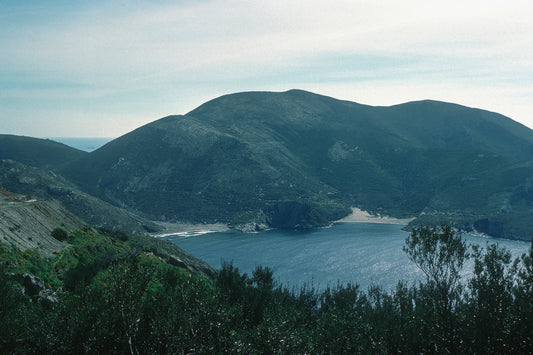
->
[62,90,533,237]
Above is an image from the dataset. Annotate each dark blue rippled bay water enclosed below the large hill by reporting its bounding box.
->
[166,223,529,290]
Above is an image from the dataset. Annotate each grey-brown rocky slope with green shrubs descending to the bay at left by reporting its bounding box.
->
[0,189,216,279]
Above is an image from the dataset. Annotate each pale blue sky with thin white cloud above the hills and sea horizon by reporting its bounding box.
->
[0,0,533,138]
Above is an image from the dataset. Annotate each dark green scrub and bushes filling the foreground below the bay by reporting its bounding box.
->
[0,225,533,354]
